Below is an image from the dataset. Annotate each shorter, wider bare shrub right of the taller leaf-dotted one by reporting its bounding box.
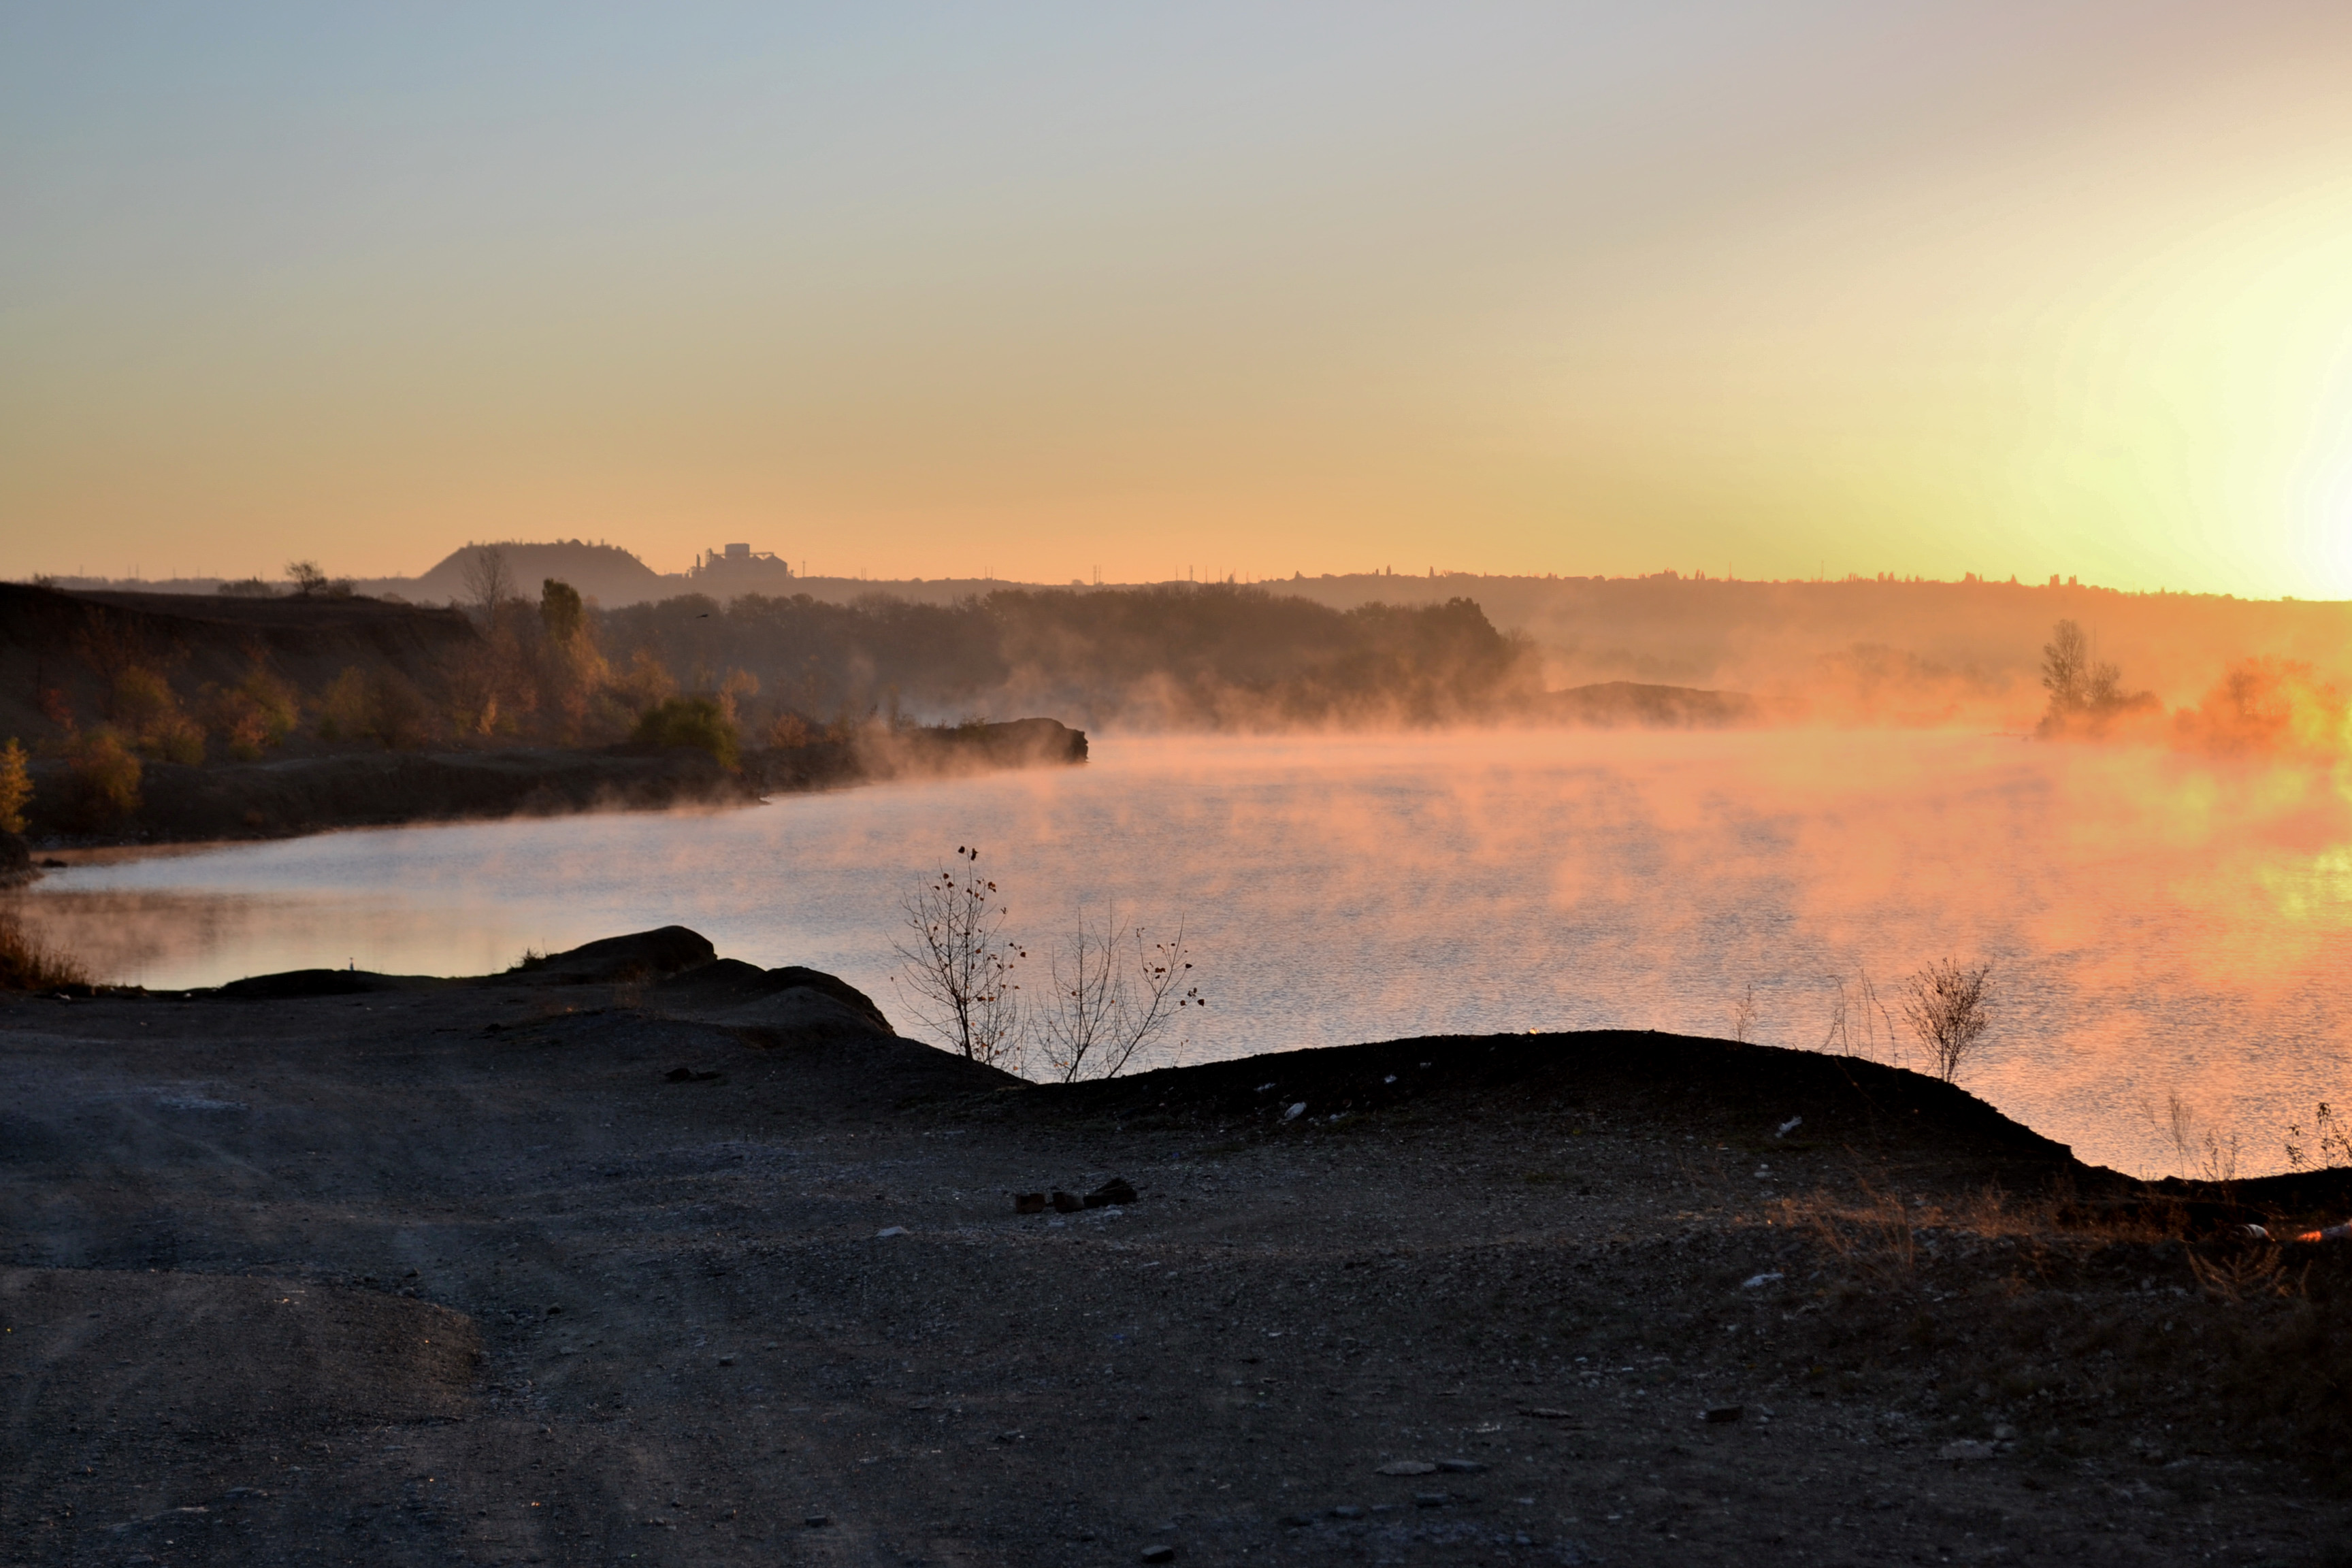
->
[1035,910,1209,1083]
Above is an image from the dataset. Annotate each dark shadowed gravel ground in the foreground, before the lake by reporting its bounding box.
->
[0,940,2352,1566]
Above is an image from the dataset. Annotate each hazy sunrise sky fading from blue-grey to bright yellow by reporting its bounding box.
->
[0,0,2352,597]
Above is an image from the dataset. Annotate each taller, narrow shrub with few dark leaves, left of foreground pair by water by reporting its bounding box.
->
[892,844,1028,1072]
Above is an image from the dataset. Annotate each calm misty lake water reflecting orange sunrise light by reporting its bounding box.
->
[21,734,2352,1173]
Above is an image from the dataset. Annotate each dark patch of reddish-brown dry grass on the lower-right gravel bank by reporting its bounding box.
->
[1778,1182,2352,1490]
